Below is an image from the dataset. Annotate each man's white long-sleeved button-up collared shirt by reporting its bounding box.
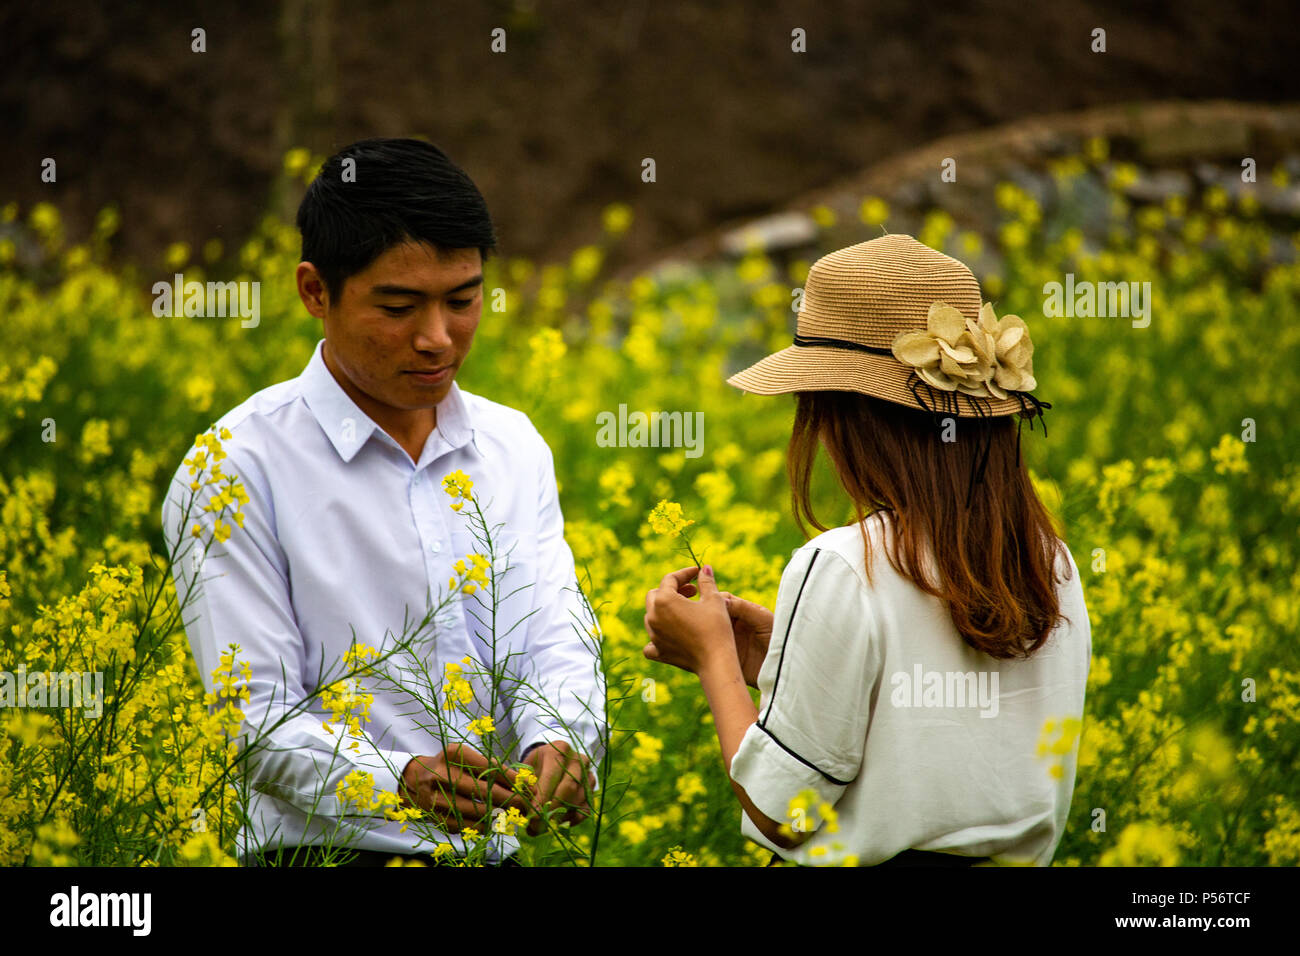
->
[163,339,605,857]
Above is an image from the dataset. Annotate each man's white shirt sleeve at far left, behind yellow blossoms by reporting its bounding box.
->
[163,442,413,818]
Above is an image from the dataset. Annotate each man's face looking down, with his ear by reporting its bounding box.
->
[298,242,482,414]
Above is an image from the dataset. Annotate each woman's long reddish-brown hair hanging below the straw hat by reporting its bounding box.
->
[787,392,1065,659]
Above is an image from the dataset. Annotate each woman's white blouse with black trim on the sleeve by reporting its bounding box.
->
[731,512,1092,865]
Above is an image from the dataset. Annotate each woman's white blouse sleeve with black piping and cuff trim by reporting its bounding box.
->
[731,548,880,849]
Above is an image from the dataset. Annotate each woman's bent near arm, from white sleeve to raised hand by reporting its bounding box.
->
[645,548,880,849]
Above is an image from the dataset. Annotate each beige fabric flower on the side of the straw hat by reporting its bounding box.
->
[892,302,1037,398]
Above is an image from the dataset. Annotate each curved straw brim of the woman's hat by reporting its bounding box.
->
[727,345,1024,418]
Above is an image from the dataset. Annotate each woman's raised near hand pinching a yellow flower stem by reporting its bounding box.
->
[644,564,736,674]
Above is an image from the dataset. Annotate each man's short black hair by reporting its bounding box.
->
[298,139,497,300]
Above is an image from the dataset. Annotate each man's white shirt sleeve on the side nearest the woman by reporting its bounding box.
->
[515,434,605,771]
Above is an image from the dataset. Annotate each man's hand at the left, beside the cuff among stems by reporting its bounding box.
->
[399,744,530,834]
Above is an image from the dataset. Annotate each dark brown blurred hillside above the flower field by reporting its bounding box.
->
[0,0,1300,265]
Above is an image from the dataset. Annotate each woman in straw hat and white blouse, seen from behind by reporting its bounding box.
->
[645,235,1092,865]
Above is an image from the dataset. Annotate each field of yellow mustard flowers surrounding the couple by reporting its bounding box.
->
[0,147,1300,866]
